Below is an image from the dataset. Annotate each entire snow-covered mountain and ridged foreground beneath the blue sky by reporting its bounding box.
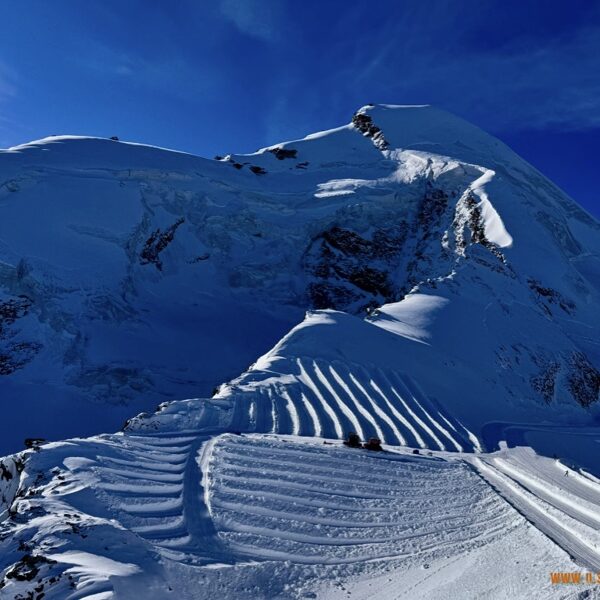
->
[0,105,600,600]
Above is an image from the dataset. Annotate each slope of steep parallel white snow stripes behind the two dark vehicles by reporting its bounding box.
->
[227,358,481,452]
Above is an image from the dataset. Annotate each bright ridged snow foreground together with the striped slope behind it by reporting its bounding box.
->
[0,368,600,600]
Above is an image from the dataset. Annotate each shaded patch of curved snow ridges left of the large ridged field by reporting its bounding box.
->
[96,433,236,564]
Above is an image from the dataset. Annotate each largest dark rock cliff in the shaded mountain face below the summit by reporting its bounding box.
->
[304,184,466,313]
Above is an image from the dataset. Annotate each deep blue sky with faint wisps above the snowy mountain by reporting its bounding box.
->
[0,0,600,216]
